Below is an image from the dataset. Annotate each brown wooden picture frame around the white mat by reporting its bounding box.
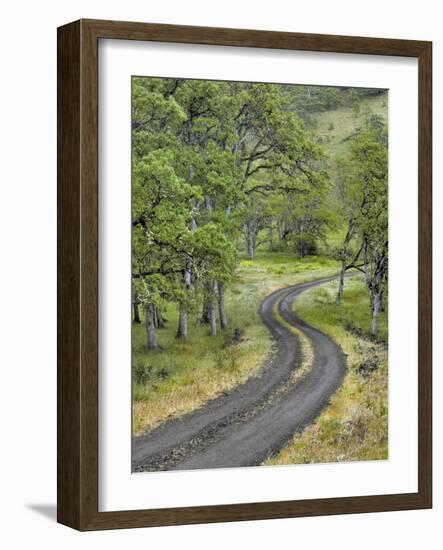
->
[57,20,432,530]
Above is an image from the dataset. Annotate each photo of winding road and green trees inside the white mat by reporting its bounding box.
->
[128,76,389,473]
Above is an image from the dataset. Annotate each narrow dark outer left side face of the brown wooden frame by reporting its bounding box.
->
[57,22,82,525]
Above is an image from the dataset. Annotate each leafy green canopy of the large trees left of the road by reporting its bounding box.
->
[132,77,334,338]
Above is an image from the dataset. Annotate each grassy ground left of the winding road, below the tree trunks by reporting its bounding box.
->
[133,251,338,435]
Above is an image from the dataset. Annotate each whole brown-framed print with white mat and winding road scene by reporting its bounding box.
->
[58,20,432,530]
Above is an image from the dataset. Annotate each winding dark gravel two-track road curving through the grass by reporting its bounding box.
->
[132,277,346,472]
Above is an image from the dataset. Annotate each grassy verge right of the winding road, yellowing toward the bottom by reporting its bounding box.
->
[265,277,388,465]
